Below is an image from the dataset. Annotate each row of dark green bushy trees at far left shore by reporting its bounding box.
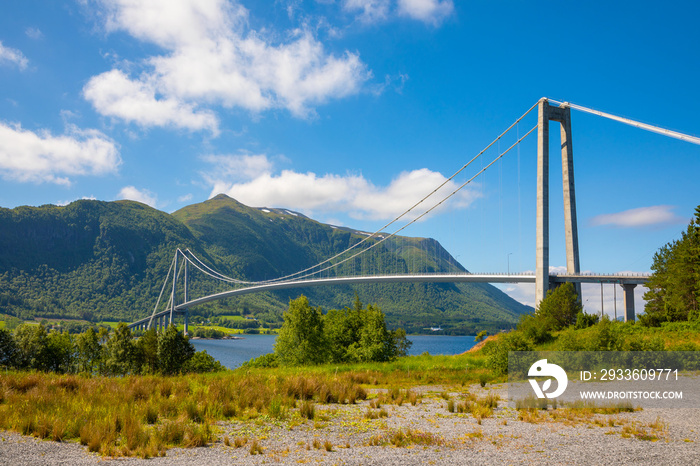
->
[0,323,224,376]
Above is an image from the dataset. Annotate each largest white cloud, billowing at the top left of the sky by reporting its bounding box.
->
[84,0,370,130]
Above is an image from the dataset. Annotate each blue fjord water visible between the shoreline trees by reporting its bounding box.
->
[191,335,475,369]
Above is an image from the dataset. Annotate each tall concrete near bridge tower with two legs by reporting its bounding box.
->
[535,98,581,306]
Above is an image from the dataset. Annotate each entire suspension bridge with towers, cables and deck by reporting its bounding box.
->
[129,98,700,333]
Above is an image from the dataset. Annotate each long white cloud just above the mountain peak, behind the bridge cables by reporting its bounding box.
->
[203,155,478,219]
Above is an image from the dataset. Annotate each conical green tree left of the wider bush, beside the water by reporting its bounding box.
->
[274,296,330,366]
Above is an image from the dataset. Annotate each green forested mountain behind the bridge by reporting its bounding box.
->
[0,195,531,333]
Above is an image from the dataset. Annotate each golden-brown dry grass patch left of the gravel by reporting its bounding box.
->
[0,372,372,457]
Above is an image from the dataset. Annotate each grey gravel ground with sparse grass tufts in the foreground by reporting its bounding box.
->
[0,386,700,466]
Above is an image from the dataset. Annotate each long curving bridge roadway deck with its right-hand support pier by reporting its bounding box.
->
[129,273,649,328]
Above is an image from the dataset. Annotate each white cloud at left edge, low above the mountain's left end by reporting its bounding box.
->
[0,123,121,185]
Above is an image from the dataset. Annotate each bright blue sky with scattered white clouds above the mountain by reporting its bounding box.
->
[0,0,700,311]
